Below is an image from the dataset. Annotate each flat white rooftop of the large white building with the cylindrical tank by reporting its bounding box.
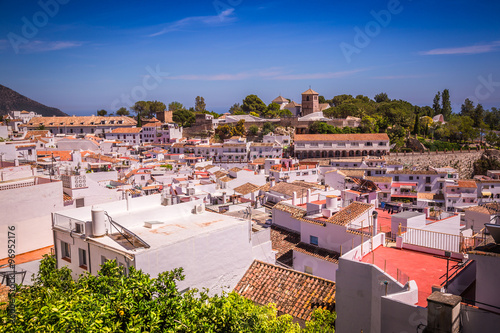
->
[55,194,248,254]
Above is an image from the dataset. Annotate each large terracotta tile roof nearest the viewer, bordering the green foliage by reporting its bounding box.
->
[234,260,335,320]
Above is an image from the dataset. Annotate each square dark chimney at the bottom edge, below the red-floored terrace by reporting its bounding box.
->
[424,291,462,333]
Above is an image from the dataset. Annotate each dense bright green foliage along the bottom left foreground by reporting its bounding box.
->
[0,256,335,332]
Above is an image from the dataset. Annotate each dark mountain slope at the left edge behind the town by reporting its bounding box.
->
[0,84,67,116]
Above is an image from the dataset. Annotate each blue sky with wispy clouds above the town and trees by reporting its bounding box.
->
[0,0,500,114]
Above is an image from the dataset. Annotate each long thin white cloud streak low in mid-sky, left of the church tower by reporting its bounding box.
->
[165,68,366,81]
